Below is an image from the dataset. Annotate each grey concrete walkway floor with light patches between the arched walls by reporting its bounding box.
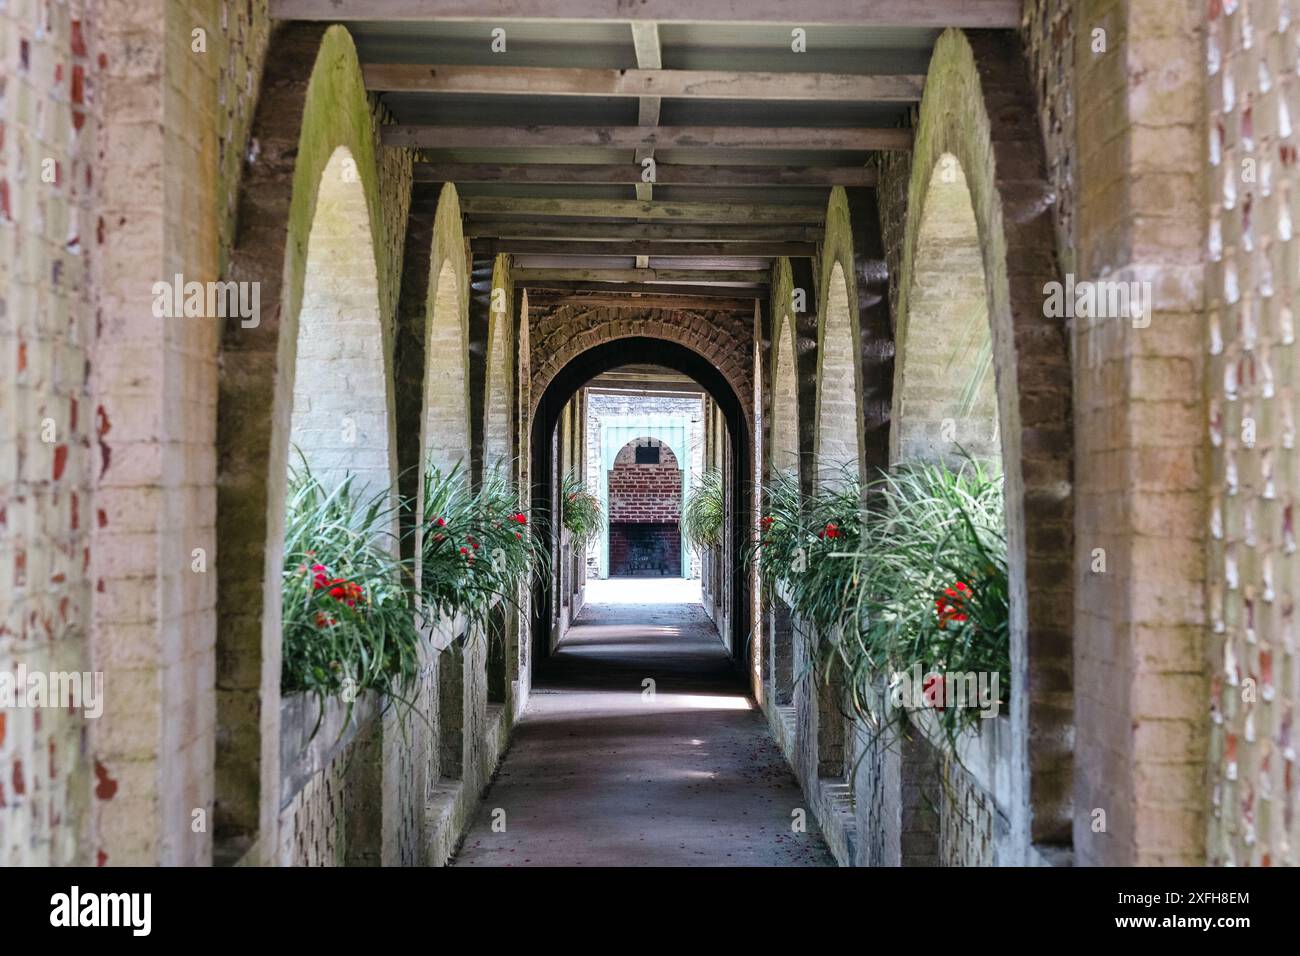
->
[452,590,835,866]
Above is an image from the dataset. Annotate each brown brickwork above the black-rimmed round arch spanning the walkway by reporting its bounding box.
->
[530,306,754,423]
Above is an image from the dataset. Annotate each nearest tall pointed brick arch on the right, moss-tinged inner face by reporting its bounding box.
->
[891,29,1074,853]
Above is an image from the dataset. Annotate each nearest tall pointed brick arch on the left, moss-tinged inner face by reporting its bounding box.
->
[215,25,395,862]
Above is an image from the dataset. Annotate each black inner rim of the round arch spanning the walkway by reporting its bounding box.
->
[530,337,751,674]
